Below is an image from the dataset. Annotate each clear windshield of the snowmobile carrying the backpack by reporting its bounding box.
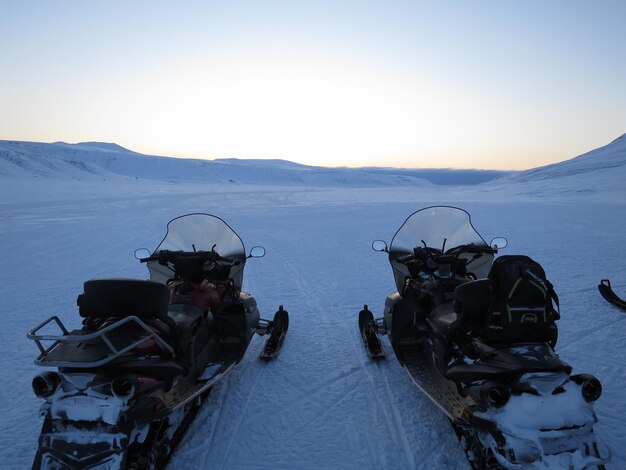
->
[389,206,493,292]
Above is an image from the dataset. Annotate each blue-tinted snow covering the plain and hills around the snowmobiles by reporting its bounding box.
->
[0,138,626,469]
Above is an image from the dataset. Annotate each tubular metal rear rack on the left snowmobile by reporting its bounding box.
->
[26,315,175,369]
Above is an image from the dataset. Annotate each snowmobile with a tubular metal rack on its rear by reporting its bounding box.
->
[27,213,289,469]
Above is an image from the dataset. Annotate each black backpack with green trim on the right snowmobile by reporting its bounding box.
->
[484,255,560,346]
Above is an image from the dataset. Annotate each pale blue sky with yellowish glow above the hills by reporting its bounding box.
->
[0,0,626,170]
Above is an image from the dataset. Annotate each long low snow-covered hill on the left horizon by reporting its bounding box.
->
[0,141,431,187]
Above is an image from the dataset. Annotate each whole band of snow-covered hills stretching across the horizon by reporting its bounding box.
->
[0,134,626,191]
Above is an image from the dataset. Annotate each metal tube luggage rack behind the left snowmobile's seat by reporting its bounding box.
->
[26,315,175,369]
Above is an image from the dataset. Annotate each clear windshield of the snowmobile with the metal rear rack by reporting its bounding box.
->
[148,214,246,290]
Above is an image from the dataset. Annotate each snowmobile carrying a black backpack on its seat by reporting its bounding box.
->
[359,206,610,469]
